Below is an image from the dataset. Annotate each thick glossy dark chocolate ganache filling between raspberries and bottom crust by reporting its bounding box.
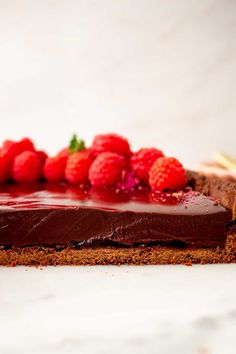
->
[0,184,232,248]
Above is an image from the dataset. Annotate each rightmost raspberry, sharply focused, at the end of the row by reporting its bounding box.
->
[149,157,187,191]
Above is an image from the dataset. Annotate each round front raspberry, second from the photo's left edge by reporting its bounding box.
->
[11,151,42,183]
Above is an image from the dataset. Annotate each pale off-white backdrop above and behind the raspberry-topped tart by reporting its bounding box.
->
[0,0,236,165]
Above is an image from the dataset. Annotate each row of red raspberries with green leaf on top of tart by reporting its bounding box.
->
[0,134,187,191]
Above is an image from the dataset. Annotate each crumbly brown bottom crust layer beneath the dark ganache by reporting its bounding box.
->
[0,235,236,266]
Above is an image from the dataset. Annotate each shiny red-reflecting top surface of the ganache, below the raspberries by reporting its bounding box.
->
[0,183,216,210]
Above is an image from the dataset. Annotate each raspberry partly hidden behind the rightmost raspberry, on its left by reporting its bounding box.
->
[131,148,164,183]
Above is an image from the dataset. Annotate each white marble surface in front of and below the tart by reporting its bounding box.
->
[0,265,236,354]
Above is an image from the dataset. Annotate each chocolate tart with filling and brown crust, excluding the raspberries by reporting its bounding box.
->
[0,172,236,266]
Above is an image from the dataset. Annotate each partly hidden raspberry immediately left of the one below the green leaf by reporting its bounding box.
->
[43,153,68,183]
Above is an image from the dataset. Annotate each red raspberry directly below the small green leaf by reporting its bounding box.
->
[65,150,93,184]
